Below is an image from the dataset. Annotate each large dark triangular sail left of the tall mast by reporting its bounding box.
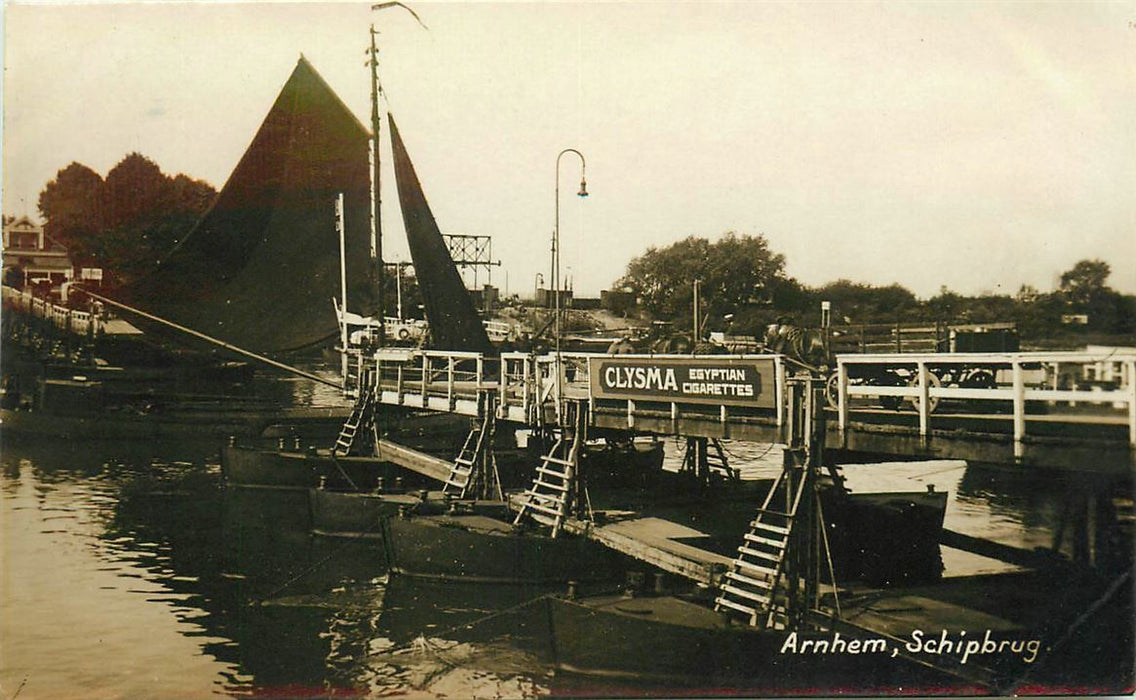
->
[124,57,375,352]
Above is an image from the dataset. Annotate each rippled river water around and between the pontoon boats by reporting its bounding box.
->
[0,377,1131,699]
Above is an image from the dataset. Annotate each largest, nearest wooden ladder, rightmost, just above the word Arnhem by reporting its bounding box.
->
[715,454,807,628]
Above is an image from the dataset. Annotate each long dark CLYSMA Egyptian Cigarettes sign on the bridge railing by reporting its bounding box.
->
[588,357,776,408]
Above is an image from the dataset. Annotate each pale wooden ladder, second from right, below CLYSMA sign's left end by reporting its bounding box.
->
[513,401,585,538]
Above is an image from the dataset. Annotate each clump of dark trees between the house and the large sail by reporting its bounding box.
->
[39,153,217,283]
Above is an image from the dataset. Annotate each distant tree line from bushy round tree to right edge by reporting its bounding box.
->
[616,233,1136,342]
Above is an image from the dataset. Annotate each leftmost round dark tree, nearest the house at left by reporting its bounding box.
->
[37,163,106,251]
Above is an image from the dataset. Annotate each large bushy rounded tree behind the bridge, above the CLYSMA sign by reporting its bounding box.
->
[616,232,785,326]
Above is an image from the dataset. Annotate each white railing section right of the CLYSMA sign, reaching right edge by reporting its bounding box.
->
[833,351,1136,455]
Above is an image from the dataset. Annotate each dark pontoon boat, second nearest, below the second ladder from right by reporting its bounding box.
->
[387,515,624,583]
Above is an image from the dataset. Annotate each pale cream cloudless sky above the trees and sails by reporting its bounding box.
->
[2,1,1136,298]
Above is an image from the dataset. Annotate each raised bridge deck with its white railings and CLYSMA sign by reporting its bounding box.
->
[359,349,1136,473]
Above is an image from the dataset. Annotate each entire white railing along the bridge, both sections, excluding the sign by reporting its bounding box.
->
[358,349,1136,453]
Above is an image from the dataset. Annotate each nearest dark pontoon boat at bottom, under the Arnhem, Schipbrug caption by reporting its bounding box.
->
[545,589,1020,697]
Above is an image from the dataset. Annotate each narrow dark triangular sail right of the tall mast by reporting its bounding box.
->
[387,114,493,352]
